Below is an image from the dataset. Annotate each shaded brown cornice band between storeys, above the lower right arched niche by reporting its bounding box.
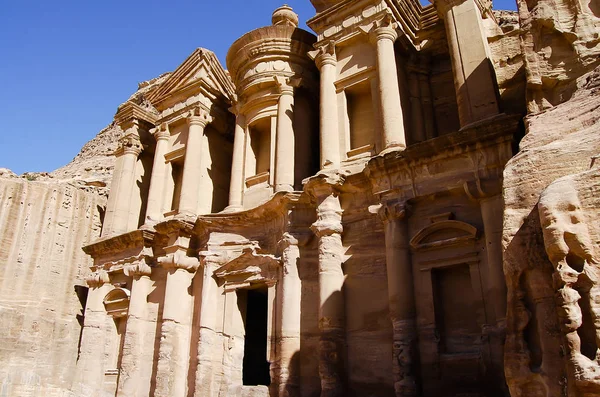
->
[365,115,521,199]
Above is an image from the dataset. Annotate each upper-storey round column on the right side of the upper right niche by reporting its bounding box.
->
[373,17,406,150]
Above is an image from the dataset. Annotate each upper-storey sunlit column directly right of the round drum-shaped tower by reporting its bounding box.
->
[309,42,340,168]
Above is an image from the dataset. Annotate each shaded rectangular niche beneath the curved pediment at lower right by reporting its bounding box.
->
[431,264,481,354]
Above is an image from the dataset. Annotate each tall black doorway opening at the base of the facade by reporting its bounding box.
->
[238,288,271,386]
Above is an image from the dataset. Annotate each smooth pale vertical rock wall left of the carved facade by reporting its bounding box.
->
[0,177,106,396]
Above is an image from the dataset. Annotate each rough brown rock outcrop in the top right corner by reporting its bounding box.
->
[517,0,600,112]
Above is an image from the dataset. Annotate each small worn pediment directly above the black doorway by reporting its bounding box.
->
[214,248,281,290]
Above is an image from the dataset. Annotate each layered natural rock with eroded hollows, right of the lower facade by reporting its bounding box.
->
[504,66,600,397]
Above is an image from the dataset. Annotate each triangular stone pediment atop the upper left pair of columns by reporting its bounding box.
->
[148,48,235,109]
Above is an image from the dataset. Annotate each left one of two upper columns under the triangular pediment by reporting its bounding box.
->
[145,125,171,224]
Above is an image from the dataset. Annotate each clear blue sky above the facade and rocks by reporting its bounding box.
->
[0,0,516,174]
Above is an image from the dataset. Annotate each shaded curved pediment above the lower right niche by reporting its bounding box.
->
[410,220,477,250]
